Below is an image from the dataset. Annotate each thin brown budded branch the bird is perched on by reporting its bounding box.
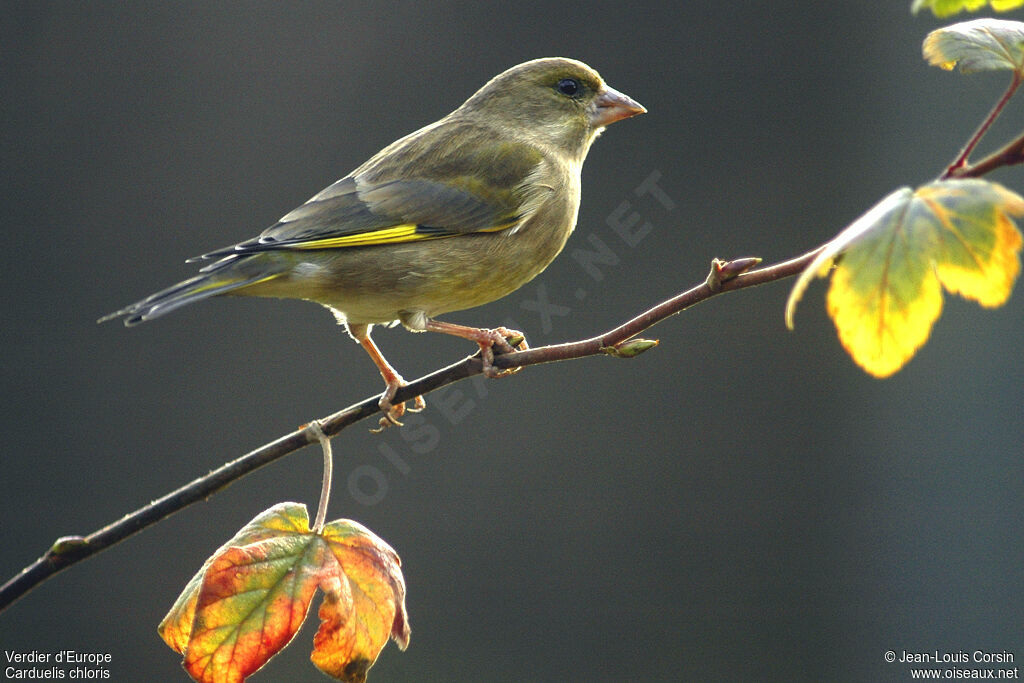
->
[0,248,820,611]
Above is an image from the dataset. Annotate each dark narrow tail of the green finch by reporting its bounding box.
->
[96,256,283,327]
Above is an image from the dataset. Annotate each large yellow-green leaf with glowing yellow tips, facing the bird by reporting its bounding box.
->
[785,179,1024,377]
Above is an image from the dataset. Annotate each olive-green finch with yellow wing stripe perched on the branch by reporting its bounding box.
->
[98,57,647,429]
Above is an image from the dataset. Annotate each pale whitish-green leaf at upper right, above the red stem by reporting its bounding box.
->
[922,18,1024,74]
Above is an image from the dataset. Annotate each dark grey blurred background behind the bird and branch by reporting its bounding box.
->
[0,0,1024,681]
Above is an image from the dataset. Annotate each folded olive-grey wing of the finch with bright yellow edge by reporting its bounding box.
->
[192,121,545,259]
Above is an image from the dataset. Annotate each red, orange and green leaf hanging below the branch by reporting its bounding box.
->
[159,503,410,683]
